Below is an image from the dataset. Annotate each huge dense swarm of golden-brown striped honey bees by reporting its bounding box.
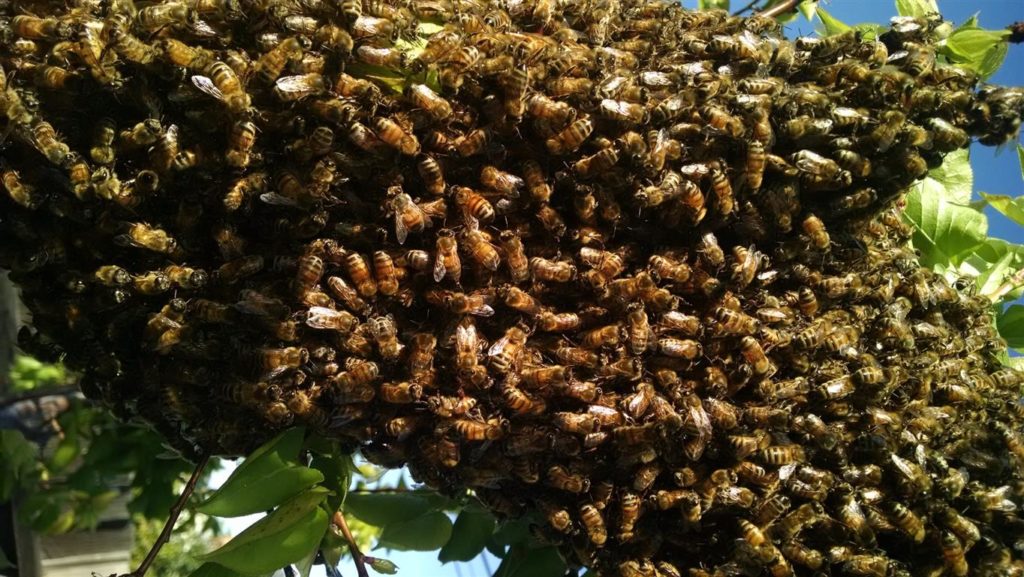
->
[0,0,1024,577]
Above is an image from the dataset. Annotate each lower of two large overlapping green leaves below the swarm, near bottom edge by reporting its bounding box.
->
[197,487,328,575]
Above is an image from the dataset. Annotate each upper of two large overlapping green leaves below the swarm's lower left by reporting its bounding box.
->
[196,428,324,517]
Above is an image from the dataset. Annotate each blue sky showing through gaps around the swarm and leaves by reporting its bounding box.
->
[216,0,1024,577]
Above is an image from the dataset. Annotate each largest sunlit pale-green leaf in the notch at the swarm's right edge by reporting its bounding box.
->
[903,178,988,267]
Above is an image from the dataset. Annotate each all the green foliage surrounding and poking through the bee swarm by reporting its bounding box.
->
[0,0,1024,577]
